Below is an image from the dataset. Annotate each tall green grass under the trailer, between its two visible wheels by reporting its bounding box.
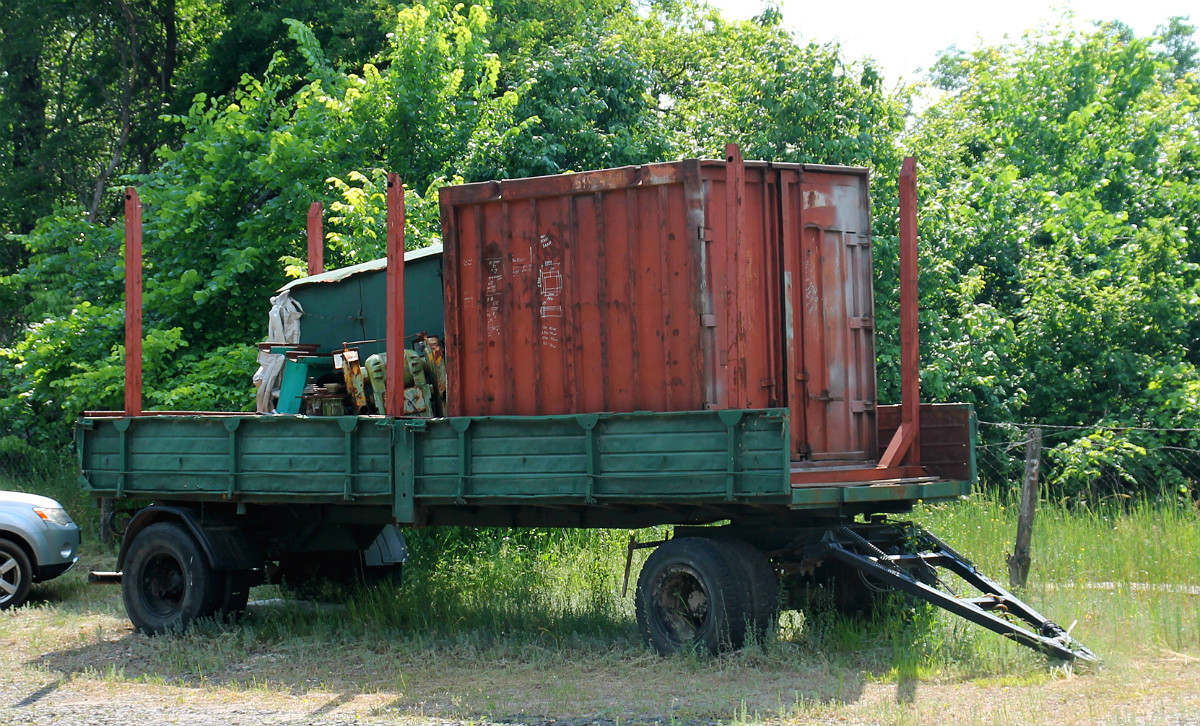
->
[249,529,636,646]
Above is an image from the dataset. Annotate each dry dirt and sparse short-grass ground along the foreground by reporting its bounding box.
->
[7,595,1200,726]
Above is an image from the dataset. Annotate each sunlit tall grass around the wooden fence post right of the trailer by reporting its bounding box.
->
[914,493,1200,660]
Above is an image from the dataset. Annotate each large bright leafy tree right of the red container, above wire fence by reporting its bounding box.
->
[907,22,1200,492]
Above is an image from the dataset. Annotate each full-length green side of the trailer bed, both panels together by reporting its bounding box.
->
[76,409,970,526]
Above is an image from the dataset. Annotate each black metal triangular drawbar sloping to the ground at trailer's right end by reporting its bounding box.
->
[822,526,1100,662]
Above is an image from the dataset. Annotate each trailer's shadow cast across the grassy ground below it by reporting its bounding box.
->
[25,590,1017,722]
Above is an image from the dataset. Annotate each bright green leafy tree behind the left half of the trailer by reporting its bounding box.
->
[0,5,522,451]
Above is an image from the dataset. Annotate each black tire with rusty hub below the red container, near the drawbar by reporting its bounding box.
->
[635,538,751,655]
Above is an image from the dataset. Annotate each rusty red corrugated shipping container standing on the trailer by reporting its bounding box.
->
[440,146,876,460]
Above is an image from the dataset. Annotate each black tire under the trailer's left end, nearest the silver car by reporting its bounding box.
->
[121,522,223,635]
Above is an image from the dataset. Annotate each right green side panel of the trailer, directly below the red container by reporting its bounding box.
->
[415,410,790,504]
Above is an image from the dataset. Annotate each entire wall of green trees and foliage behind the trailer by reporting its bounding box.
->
[0,0,1200,504]
